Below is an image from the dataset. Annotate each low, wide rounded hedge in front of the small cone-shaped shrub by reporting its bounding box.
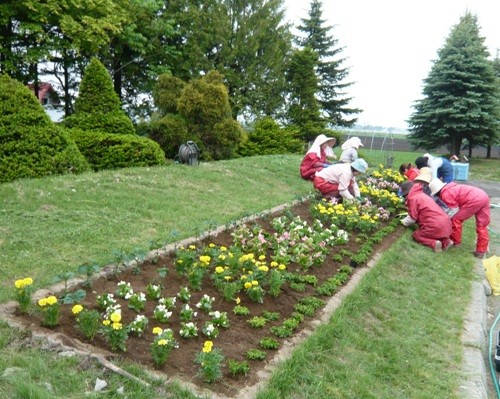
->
[71,129,165,171]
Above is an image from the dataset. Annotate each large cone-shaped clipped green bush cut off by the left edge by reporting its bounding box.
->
[0,75,89,182]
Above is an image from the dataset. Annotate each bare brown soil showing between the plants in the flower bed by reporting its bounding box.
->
[10,203,401,397]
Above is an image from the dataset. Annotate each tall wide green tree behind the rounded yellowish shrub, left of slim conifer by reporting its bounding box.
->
[165,0,291,118]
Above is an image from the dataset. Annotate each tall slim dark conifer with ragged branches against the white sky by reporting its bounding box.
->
[295,0,361,126]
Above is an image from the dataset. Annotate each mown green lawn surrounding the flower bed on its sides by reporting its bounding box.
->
[0,154,500,399]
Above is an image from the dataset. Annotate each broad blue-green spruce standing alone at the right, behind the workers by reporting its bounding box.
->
[408,12,499,155]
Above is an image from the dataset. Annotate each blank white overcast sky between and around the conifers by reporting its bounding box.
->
[284,0,500,128]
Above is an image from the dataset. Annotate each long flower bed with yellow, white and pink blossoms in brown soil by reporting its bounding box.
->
[7,167,401,396]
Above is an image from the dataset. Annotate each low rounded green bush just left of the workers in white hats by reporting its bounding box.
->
[238,117,304,157]
